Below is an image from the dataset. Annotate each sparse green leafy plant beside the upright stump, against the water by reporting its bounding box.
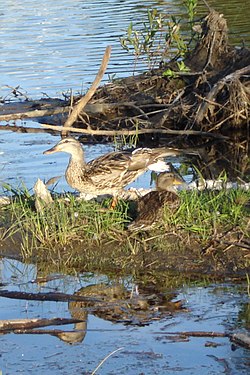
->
[120,0,197,72]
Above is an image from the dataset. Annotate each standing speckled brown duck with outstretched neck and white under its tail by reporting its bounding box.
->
[44,137,186,198]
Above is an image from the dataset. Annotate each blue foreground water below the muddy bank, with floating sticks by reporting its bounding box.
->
[0,259,249,375]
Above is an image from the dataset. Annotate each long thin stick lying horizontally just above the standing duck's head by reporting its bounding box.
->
[41,124,229,140]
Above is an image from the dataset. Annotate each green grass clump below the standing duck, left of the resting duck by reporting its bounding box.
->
[2,191,130,257]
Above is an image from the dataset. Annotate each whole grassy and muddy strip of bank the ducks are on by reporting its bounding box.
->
[0,190,250,277]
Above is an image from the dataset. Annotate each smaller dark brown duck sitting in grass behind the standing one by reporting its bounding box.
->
[128,169,185,231]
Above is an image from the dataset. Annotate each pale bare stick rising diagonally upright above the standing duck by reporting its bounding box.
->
[62,46,111,135]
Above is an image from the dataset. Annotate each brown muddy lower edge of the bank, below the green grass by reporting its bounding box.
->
[0,213,250,280]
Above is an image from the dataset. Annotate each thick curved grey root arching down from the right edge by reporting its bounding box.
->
[196,65,250,123]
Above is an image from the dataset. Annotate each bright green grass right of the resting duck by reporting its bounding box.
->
[164,190,250,240]
